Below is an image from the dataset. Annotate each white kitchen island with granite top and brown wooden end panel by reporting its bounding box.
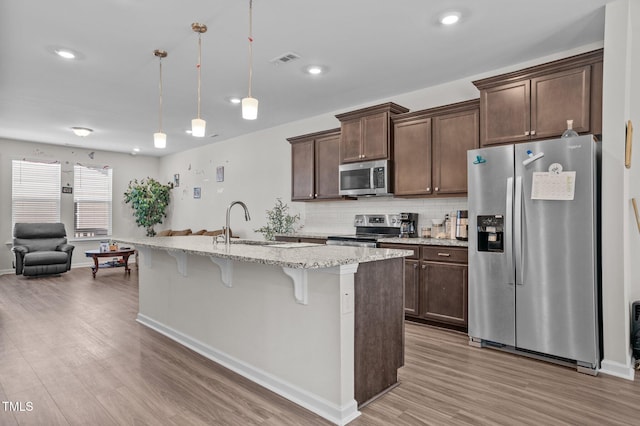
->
[118,236,411,424]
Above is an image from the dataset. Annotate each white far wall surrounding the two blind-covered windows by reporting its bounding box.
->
[0,139,160,273]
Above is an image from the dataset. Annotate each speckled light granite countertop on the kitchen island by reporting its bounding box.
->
[112,235,413,269]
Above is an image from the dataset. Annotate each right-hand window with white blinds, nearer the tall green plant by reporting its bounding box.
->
[73,165,112,237]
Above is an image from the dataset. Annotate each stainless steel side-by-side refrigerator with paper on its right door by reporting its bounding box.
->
[467,135,600,374]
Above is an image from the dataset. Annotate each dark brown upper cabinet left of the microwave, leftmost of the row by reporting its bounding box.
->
[287,129,341,201]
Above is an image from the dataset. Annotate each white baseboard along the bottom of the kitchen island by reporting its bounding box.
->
[136,313,360,425]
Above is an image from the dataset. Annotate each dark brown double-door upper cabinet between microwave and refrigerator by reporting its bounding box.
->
[393,99,479,197]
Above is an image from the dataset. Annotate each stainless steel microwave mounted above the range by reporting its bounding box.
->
[339,160,393,197]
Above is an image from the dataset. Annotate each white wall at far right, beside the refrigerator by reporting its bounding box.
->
[602,0,640,377]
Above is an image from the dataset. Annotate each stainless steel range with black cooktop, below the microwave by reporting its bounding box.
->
[327,213,418,247]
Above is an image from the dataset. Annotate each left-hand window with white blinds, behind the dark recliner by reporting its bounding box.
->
[11,160,61,229]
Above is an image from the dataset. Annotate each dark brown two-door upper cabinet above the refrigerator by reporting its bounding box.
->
[473,49,603,146]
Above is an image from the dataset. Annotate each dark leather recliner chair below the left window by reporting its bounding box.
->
[13,223,74,276]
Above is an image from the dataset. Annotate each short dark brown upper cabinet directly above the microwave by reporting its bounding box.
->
[336,102,409,164]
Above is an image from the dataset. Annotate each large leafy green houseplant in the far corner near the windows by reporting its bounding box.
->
[124,177,173,237]
